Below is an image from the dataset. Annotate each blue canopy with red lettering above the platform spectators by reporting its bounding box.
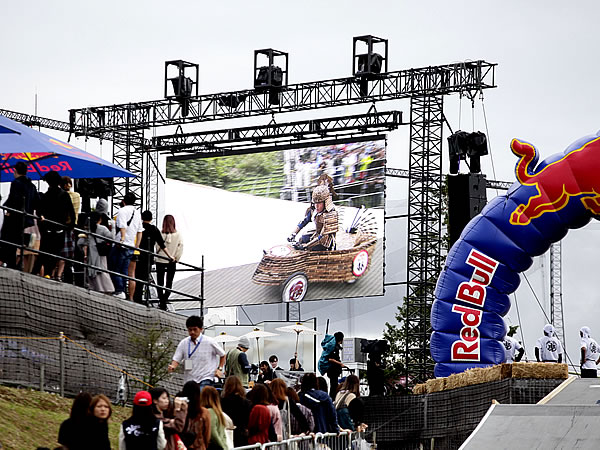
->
[0,115,135,182]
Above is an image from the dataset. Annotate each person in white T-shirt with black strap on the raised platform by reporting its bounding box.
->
[109,192,144,300]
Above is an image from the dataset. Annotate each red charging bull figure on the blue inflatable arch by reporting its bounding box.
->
[510,138,600,225]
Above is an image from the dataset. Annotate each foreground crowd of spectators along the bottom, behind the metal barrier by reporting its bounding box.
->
[52,373,366,450]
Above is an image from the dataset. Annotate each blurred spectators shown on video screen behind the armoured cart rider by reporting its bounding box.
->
[282,142,385,207]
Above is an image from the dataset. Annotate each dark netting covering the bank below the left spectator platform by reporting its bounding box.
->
[0,269,186,400]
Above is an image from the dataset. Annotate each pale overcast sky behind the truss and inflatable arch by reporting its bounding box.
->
[0,0,600,370]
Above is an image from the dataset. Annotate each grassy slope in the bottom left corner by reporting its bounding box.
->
[0,386,131,450]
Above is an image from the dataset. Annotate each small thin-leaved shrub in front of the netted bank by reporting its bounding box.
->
[129,323,175,386]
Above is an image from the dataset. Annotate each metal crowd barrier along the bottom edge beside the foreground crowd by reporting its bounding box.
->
[233,431,377,450]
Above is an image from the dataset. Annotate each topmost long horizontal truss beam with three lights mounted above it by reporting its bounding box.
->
[70,61,496,136]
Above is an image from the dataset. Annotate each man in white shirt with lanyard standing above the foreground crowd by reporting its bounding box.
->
[169,316,225,389]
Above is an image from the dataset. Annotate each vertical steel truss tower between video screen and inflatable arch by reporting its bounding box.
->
[404,96,444,385]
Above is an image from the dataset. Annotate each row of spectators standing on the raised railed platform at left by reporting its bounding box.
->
[0,161,183,310]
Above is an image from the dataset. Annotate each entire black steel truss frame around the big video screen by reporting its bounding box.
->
[2,61,496,384]
